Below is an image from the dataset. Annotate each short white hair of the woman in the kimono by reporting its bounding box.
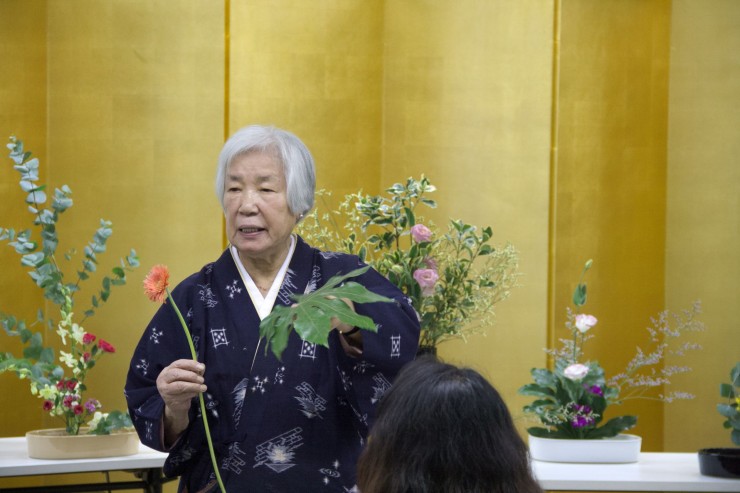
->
[216,125,316,217]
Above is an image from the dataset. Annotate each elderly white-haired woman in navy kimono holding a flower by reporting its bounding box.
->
[126,126,419,492]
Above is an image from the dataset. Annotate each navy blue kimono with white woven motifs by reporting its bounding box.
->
[125,238,419,493]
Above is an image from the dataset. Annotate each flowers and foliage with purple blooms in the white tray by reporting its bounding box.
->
[519,260,704,439]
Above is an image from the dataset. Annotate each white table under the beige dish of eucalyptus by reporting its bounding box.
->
[0,437,167,493]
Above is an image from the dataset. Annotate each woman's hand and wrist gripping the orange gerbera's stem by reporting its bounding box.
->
[157,359,206,447]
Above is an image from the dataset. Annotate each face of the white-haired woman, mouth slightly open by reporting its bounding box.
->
[224,152,297,263]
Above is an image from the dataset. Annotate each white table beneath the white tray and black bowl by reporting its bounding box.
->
[532,453,740,492]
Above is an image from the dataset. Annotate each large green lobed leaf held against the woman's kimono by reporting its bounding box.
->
[260,266,393,359]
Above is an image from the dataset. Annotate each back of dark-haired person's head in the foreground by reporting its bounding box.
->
[357,356,542,493]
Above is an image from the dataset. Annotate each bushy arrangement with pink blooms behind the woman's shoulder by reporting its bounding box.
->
[298,176,518,348]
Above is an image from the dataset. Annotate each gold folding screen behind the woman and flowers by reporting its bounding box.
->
[0,4,740,480]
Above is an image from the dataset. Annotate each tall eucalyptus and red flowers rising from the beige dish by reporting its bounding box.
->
[0,137,138,435]
